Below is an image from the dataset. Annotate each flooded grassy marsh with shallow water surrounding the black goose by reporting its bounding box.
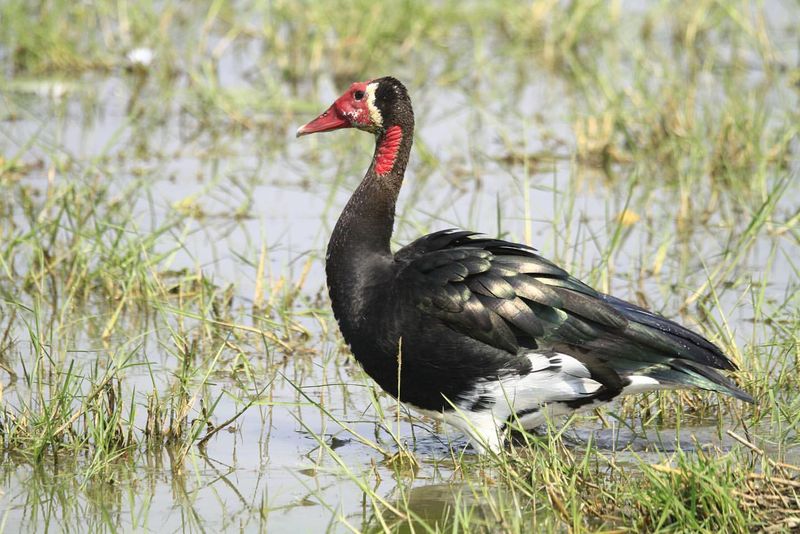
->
[0,0,800,532]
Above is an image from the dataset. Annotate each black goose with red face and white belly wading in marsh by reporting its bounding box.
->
[297,76,754,453]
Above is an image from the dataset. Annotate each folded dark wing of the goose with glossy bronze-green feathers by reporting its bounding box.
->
[395,230,749,400]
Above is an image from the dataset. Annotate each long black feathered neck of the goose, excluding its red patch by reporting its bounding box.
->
[325,118,414,344]
